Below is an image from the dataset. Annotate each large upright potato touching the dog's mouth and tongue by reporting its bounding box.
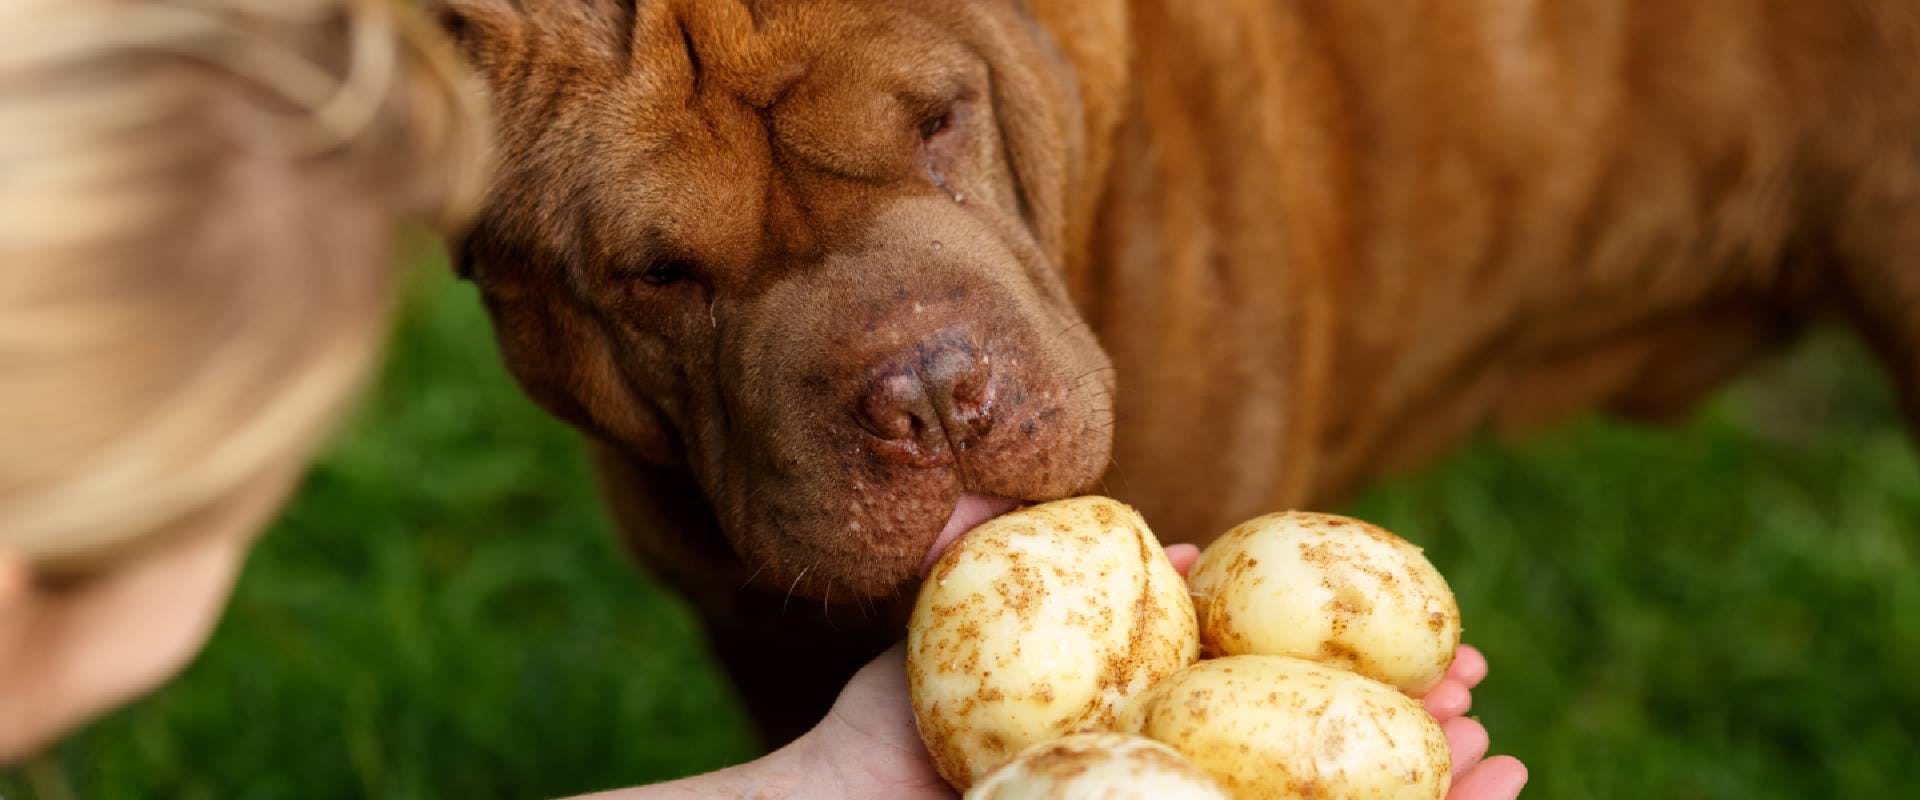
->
[906,497,1200,790]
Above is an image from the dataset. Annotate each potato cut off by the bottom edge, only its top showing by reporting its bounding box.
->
[966,733,1227,800]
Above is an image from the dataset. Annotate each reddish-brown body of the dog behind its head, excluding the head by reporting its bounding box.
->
[1096,0,1920,533]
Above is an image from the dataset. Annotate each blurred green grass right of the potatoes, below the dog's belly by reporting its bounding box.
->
[1356,331,1920,798]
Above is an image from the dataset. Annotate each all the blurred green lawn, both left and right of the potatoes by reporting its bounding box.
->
[0,257,1920,798]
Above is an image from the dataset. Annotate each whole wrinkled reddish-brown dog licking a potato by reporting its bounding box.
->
[438,0,1920,741]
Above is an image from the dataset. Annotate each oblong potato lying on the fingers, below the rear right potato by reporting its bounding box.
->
[1121,656,1452,800]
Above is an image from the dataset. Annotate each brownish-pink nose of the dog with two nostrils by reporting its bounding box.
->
[858,334,993,464]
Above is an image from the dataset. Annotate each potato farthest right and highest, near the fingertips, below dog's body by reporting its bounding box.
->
[1187,512,1459,694]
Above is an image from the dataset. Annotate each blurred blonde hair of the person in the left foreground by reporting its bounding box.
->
[0,0,486,570]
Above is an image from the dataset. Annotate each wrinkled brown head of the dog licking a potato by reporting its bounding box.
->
[426,0,1114,597]
